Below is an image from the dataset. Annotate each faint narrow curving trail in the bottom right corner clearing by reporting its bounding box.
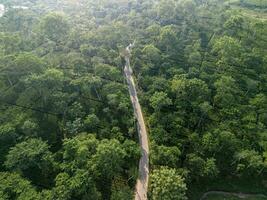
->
[200,191,267,200]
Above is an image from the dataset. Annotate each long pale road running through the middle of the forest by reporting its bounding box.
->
[124,44,149,200]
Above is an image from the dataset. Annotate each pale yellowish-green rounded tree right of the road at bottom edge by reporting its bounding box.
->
[150,167,187,200]
